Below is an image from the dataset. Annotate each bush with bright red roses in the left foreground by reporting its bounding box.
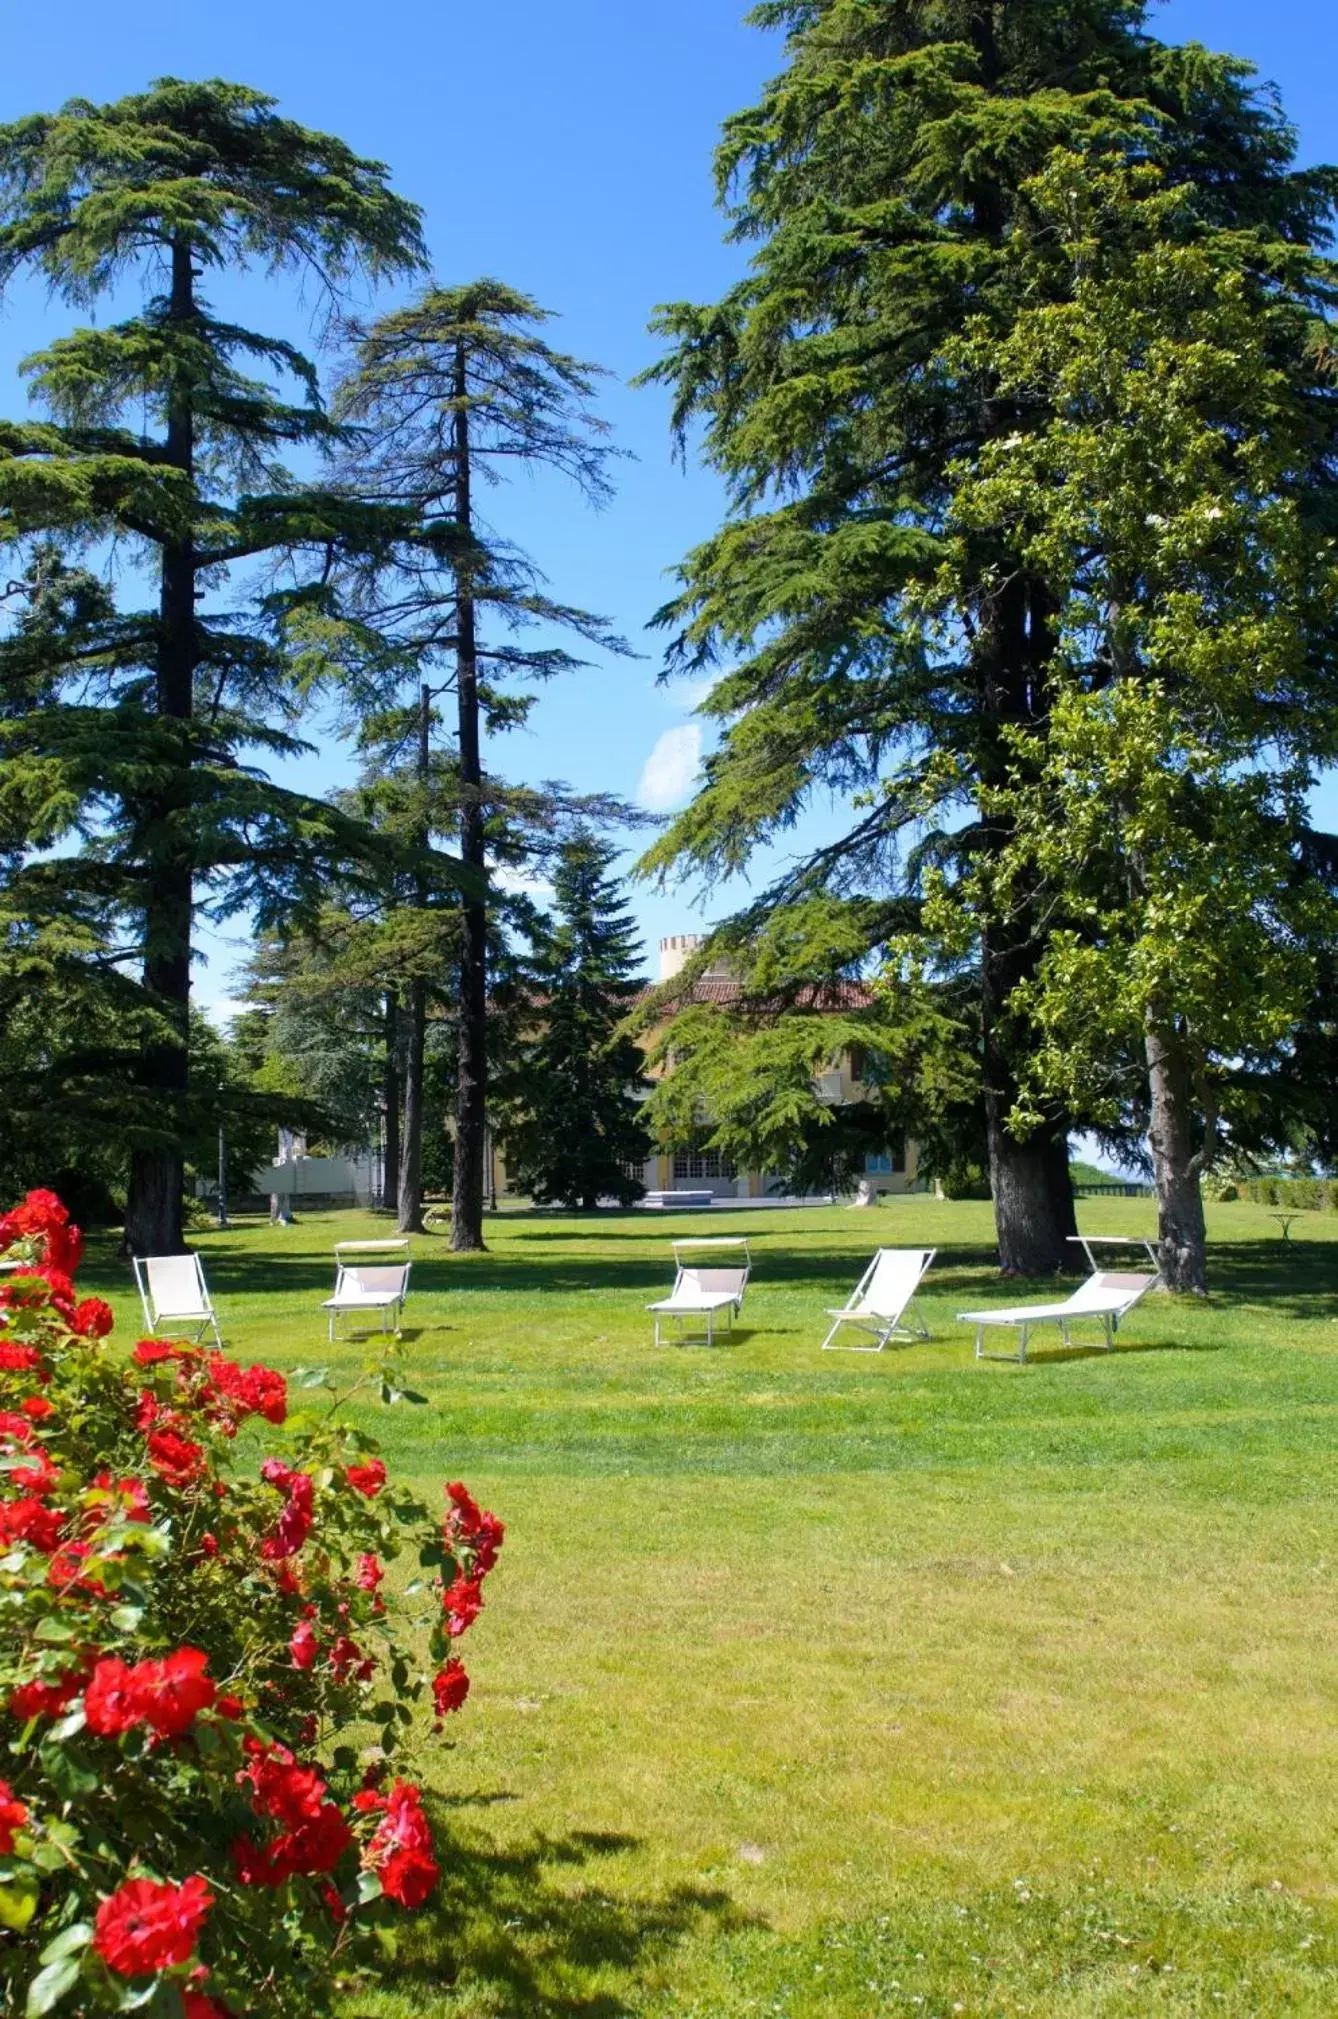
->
[0,1191,503,2019]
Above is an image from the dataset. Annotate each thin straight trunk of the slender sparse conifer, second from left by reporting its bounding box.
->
[450,343,488,1252]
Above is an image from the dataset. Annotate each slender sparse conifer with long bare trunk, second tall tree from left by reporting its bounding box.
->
[337,281,628,1250]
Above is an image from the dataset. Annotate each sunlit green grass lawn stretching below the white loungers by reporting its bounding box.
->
[87,1199,1338,2019]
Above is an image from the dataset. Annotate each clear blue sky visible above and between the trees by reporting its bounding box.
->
[0,0,1338,1007]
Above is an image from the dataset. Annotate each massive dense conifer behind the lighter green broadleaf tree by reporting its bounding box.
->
[648,0,1328,1272]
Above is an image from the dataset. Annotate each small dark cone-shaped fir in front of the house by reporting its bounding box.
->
[498,834,650,1211]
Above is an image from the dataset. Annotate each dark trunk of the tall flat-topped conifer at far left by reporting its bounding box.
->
[125,234,196,1254]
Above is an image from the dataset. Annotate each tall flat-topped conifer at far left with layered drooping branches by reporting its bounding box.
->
[0,79,422,1252]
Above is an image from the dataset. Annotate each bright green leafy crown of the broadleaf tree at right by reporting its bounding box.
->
[928,155,1338,1211]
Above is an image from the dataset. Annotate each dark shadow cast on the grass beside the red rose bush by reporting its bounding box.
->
[355,1795,759,2019]
